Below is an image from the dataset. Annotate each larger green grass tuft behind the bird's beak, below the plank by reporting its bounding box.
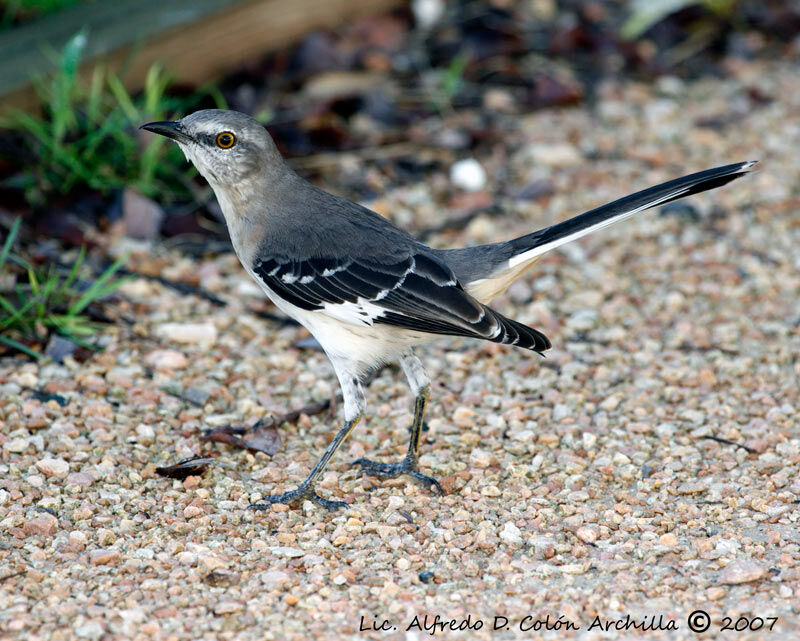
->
[0,29,224,206]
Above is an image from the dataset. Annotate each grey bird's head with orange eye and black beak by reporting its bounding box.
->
[141,109,283,194]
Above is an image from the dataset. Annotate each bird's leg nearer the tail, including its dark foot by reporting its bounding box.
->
[352,352,442,494]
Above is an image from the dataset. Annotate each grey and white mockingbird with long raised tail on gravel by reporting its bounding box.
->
[142,109,755,510]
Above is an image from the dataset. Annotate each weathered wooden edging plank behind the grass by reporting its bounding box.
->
[0,0,400,108]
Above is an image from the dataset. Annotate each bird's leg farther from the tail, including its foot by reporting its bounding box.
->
[250,372,366,510]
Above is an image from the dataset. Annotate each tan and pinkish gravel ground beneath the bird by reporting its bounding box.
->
[0,57,800,640]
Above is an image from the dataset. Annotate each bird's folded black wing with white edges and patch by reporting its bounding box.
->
[254,253,549,351]
